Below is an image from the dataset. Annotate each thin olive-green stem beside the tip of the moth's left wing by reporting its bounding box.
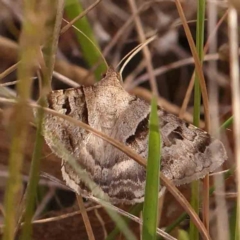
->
[21,0,64,237]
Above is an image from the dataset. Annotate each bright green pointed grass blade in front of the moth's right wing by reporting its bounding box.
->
[142,97,161,240]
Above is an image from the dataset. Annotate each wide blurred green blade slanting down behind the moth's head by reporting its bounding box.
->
[65,0,106,80]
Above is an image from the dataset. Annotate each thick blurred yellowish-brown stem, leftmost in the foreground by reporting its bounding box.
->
[2,0,41,240]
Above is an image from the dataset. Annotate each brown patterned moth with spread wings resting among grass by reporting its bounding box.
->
[40,68,227,204]
